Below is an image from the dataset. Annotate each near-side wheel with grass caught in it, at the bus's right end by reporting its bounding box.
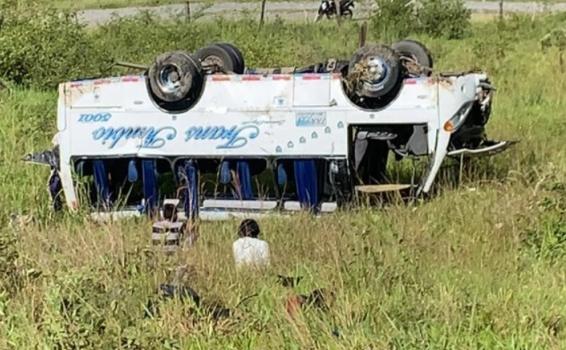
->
[346,45,402,99]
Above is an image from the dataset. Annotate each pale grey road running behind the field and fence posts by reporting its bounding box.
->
[78,1,566,26]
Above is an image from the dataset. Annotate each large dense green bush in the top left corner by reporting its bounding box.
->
[0,0,108,87]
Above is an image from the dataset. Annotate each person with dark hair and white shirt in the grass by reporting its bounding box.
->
[232,219,269,267]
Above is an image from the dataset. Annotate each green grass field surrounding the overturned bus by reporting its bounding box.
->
[0,8,566,350]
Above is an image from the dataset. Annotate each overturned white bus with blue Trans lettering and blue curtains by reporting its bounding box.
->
[27,40,509,217]
